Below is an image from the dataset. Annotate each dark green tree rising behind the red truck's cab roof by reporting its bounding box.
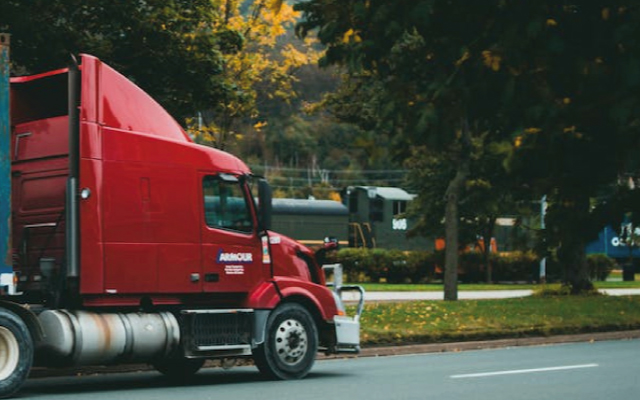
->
[0,0,230,121]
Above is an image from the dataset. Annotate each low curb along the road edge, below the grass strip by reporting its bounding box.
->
[29,330,640,379]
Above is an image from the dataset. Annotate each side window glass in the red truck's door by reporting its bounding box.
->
[202,176,253,232]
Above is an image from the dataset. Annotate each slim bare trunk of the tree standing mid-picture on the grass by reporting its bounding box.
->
[444,121,471,301]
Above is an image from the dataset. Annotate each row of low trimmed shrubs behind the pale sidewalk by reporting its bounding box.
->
[337,248,616,283]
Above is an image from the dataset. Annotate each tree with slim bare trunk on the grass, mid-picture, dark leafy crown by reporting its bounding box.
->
[298,0,528,300]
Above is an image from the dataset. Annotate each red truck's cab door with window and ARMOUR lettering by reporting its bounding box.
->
[201,173,262,293]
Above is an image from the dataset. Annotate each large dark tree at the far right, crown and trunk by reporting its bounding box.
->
[502,1,640,293]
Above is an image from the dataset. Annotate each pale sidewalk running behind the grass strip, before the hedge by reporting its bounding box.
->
[342,288,640,302]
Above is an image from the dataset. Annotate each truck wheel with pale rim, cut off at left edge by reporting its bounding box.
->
[0,309,33,398]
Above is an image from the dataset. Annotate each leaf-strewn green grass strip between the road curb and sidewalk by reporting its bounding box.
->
[350,296,640,346]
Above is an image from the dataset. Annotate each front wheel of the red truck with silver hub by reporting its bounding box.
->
[254,303,318,380]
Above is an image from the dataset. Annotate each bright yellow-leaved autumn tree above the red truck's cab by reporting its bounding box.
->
[189,0,320,149]
